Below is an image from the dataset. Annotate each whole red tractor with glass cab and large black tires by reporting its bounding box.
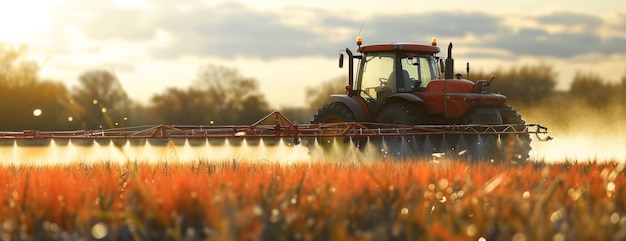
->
[311,37,531,162]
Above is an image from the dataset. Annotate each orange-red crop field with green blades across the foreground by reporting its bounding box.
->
[0,160,626,240]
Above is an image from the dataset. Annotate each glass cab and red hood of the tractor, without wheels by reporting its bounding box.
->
[335,37,506,123]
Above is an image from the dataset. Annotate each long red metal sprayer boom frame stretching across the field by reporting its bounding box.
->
[0,112,552,143]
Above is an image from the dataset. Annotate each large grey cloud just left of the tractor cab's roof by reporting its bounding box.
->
[154,4,324,58]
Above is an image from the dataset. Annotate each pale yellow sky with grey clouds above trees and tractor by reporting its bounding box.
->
[0,0,626,109]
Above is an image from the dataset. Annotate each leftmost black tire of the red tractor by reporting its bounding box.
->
[308,102,356,152]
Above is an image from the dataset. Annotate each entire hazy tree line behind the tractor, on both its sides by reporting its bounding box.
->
[0,44,626,131]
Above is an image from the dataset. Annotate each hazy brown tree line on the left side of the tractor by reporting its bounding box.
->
[0,44,278,131]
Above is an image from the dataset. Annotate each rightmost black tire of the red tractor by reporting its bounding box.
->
[500,105,532,162]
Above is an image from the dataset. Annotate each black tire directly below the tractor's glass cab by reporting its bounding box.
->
[376,101,428,160]
